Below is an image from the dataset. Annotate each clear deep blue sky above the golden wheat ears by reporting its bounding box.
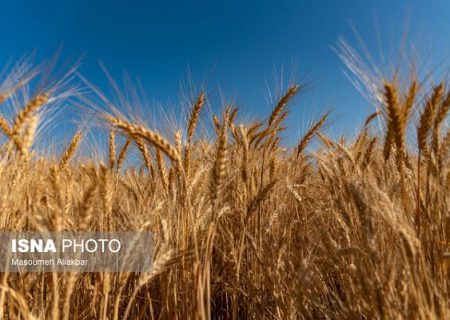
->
[0,0,450,141]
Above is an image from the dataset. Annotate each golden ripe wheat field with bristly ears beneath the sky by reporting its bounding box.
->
[0,58,450,320]
